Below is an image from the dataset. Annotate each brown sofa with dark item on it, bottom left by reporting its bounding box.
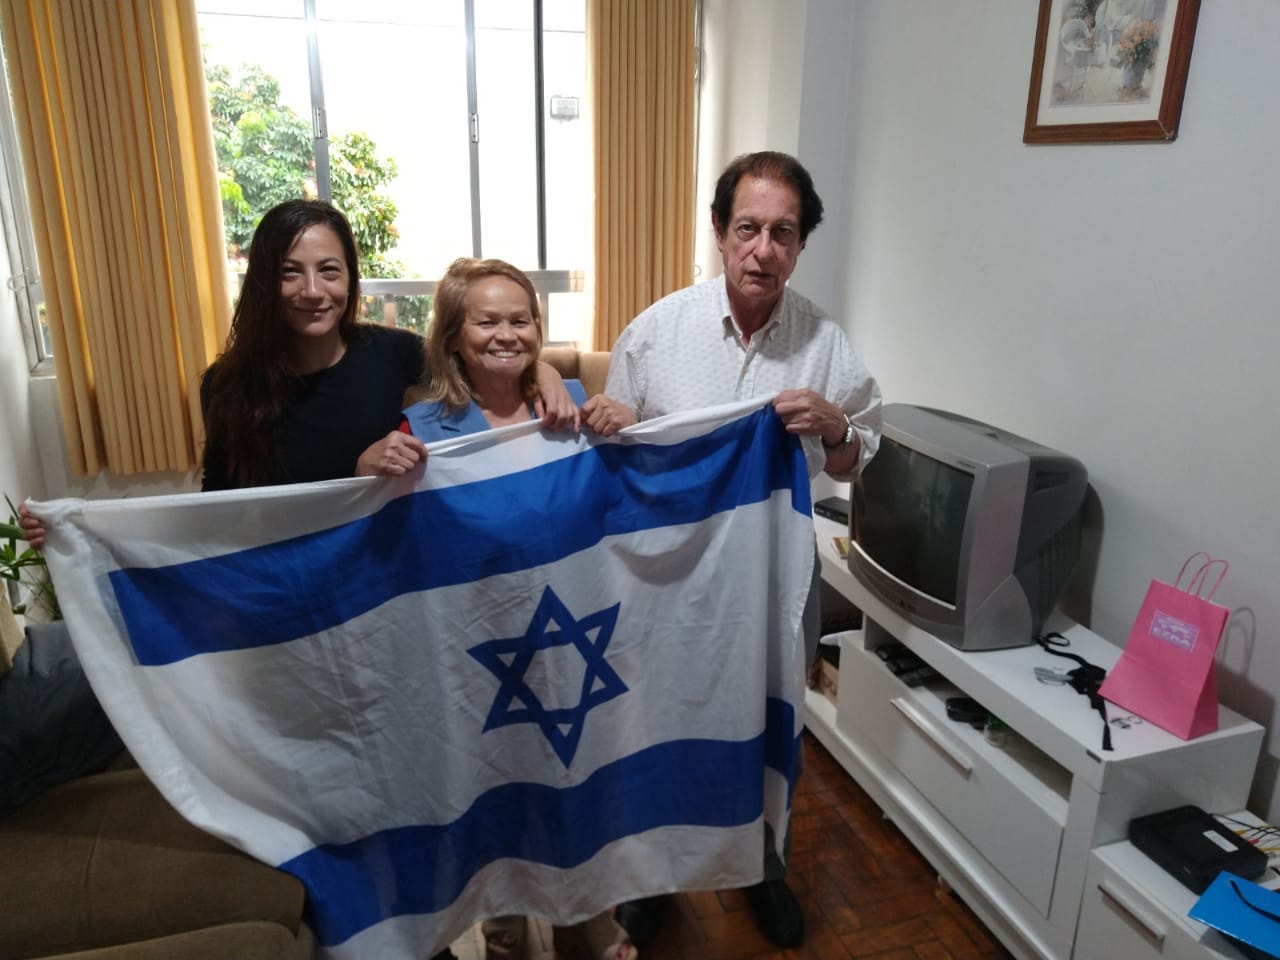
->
[0,632,315,960]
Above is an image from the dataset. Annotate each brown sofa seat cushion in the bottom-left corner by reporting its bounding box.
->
[0,769,303,960]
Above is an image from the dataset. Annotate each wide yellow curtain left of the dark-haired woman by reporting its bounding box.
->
[0,0,230,474]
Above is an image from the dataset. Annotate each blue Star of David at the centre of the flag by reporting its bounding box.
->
[467,586,627,767]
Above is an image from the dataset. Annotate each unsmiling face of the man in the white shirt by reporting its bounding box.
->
[714,177,804,326]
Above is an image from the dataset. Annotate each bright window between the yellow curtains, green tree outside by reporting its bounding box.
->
[197,0,590,342]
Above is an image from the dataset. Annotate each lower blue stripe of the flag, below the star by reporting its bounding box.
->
[288,699,800,946]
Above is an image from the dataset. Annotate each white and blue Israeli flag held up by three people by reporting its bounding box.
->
[42,401,814,957]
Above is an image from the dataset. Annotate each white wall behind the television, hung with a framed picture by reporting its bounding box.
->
[778,0,1280,822]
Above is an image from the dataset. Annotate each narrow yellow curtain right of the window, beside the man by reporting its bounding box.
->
[586,0,694,349]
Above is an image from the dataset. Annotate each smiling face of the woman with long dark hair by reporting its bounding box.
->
[280,224,351,348]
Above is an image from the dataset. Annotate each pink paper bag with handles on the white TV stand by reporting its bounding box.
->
[1098,553,1230,740]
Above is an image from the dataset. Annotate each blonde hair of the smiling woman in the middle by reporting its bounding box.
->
[404,257,543,410]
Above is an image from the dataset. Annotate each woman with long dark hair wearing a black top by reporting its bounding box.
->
[200,200,577,490]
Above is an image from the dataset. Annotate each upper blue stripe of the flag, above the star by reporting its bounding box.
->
[110,406,809,666]
